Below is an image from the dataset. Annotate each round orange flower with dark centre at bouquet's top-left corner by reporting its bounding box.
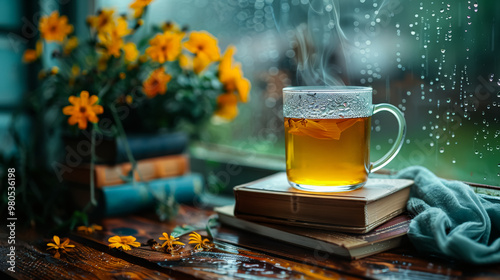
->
[39,11,73,42]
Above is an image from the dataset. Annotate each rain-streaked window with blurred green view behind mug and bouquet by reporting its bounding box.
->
[0,0,500,190]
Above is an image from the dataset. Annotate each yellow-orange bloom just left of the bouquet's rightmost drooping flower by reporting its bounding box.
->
[184,31,220,73]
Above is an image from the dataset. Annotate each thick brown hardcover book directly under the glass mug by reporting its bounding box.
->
[234,172,413,233]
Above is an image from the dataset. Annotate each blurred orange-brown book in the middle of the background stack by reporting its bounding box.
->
[64,154,189,188]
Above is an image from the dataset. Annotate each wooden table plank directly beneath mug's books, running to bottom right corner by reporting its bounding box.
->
[217,219,500,279]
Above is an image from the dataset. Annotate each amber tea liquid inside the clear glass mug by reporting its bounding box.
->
[285,117,371,186]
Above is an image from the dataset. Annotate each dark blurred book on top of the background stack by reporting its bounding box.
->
[115,133,188,163]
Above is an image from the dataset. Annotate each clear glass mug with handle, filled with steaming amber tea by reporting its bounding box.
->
[283,86,406,192]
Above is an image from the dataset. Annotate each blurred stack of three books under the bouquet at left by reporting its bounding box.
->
[63,133,203,216]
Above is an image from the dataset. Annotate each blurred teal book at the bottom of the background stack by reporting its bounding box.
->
[99,173,203,216]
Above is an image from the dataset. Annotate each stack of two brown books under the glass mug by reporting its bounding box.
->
[216,173,413,259]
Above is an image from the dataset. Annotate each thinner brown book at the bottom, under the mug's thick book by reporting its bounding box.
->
[215,205,411,259]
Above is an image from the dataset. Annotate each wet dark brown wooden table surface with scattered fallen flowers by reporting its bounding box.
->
[0,206,500,279]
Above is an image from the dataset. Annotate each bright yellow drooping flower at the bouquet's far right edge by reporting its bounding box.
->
[219,46,250,102]
